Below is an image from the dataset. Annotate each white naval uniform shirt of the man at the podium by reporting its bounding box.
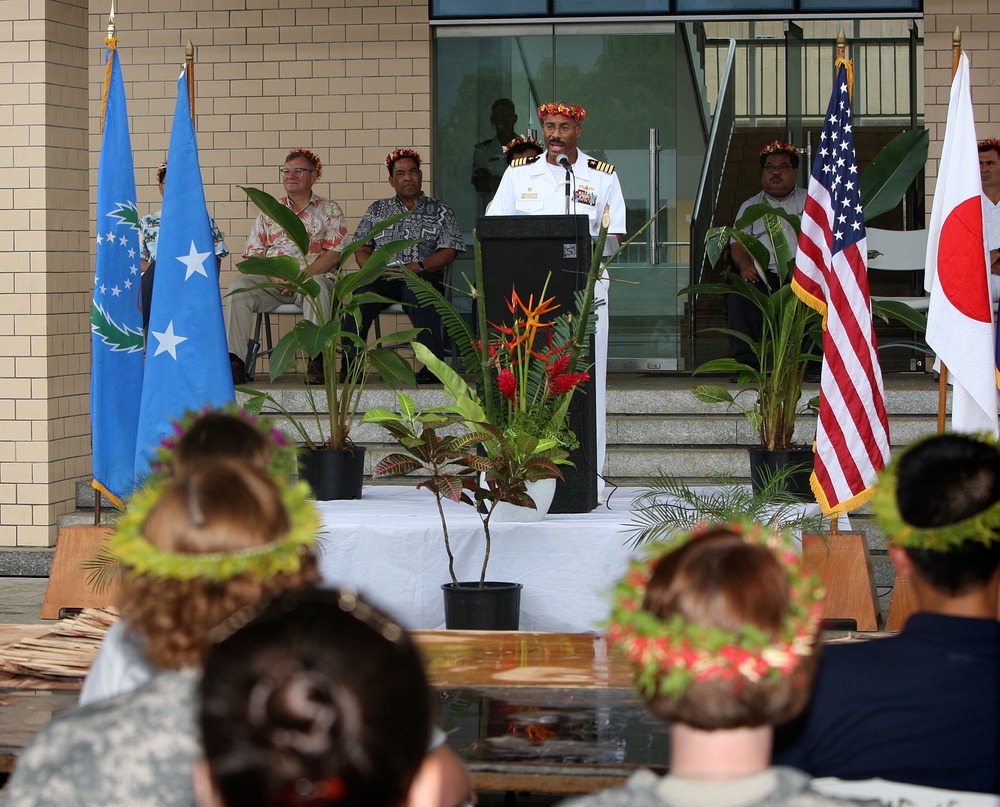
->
[486,149,625,255]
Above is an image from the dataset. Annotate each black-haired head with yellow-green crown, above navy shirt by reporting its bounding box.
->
[876,434,1000,597]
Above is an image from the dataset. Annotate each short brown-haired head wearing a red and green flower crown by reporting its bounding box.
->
[610,525,822,731]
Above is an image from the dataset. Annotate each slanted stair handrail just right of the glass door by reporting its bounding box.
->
[687,39,736,334]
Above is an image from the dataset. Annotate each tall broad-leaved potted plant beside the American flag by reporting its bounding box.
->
[679,131,928,497]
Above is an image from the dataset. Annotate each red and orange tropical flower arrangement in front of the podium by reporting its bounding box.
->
[489,288,590,453]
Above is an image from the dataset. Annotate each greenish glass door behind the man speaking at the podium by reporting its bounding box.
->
[434,23,705,372]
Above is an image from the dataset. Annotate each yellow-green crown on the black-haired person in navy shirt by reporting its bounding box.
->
[872,435,1000,552]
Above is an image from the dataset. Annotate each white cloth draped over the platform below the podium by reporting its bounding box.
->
[319,485,639,633]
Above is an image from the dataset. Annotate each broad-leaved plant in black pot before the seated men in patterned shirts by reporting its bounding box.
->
[237,188,417,499]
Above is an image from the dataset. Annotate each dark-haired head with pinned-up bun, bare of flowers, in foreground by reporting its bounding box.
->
[200,590,430,807]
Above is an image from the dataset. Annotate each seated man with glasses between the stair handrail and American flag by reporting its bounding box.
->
[727,140,807,381]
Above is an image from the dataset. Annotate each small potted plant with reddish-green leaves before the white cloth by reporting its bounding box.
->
[364,393,561,630]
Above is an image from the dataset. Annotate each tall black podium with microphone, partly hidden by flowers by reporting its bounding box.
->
[476,216,592,513]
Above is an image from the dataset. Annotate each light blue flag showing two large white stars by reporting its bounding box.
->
[135,72,234,477]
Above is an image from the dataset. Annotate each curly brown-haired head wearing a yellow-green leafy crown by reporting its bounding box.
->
[109,460,318,668]
